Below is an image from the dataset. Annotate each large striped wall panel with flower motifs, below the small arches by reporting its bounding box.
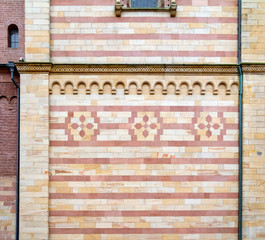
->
[49,92,238,240]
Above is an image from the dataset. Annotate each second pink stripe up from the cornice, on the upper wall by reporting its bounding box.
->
[51,33,237,40]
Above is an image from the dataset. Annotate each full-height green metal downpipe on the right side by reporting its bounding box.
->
[238,0,243,240]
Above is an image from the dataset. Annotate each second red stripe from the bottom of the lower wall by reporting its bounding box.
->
[49,210,238,217]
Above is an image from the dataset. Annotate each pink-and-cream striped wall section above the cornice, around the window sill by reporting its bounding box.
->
[47,0,237,63]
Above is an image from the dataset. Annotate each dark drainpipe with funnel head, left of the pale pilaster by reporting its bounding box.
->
[7,62,20,240]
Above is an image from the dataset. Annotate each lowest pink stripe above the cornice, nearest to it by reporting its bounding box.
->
[51,51,237,57]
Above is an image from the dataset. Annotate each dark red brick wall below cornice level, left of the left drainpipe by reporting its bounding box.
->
[0,69,18,240]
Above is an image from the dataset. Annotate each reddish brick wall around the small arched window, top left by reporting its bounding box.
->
[0,0,25,63]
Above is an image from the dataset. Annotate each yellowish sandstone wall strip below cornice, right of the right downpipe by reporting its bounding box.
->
[243,74,265,240]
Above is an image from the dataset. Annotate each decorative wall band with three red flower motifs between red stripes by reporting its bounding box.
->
[50,106,238,147]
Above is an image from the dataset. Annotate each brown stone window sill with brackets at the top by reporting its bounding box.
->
[115,0,174,17]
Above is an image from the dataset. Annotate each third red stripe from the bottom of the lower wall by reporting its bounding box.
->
[49,193,238,199]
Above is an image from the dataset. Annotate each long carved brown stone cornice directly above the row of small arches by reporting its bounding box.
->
[16,62,238,74]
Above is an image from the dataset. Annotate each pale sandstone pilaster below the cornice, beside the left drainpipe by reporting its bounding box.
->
[20,74,49,240]
